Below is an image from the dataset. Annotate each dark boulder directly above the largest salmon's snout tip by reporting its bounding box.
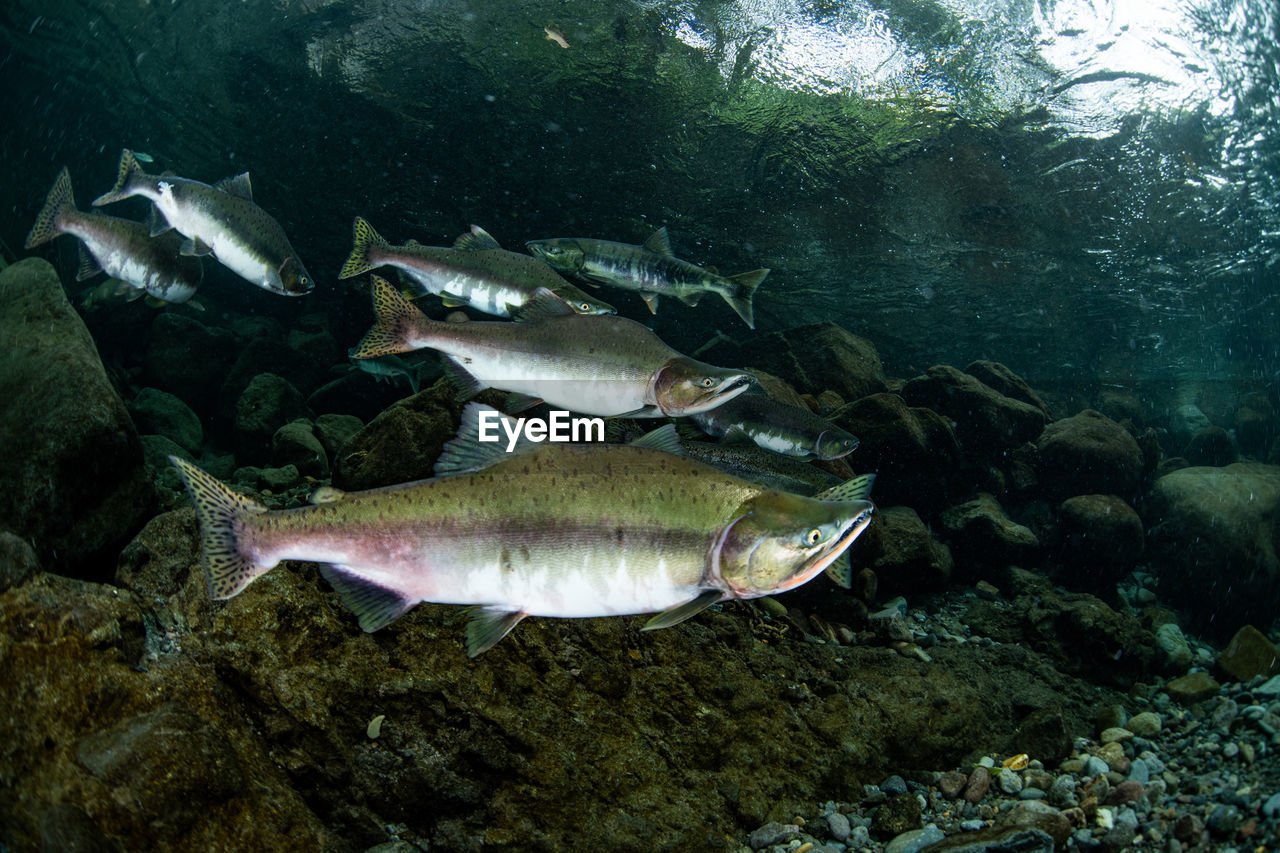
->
[831,393,960,517]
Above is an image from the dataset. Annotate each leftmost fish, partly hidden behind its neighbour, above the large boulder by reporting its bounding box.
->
[27,168,205,302]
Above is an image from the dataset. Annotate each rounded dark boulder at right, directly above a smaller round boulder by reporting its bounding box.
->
[1036,409,1144,498]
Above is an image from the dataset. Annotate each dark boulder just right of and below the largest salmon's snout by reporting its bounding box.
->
[849,506,952,601]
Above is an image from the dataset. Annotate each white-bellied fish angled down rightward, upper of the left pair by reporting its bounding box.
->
[93,150,315,296]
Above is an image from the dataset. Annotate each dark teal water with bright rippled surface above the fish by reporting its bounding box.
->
[0,0,1280,382]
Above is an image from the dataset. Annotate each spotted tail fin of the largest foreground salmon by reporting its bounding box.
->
[169,456,275,598]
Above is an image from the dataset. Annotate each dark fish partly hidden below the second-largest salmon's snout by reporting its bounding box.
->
[692,393,858,460]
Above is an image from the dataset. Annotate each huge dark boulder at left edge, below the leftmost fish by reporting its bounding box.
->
[0,259,156,578]
